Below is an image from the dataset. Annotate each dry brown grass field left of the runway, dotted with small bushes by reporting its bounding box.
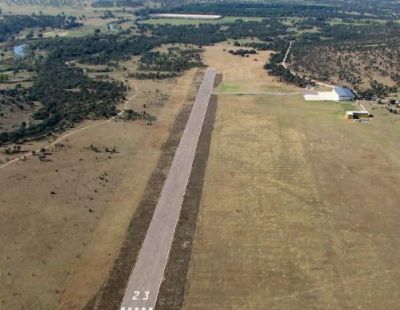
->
[0,65,202,309]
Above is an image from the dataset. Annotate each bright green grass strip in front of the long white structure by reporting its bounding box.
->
[141,16,262,25]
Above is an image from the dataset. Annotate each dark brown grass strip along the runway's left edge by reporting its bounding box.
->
[85,70,205,309]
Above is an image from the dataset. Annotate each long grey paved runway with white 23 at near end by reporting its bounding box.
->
[121,68,216,310]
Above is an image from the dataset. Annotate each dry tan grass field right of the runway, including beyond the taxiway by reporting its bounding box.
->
[183,46,400,310]
